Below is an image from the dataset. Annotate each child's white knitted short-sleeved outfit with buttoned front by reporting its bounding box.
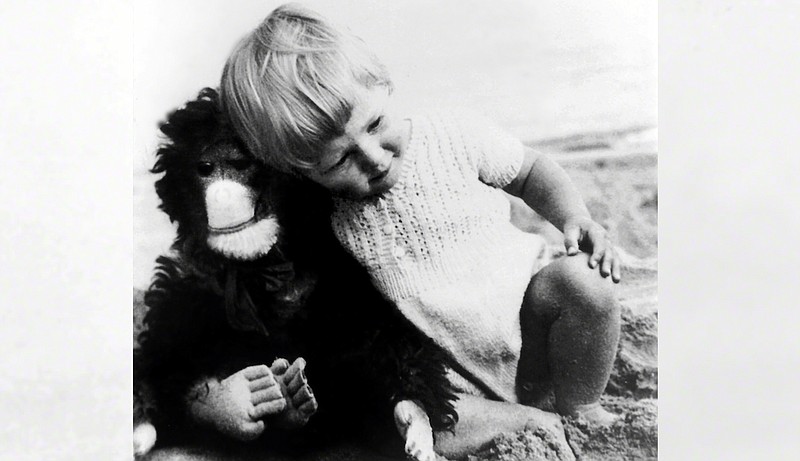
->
[331,115,546,402]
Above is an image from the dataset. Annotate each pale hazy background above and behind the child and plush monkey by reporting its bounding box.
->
[133,0,657,288]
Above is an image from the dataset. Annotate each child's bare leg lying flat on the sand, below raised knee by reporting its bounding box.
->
[435,395,572,459]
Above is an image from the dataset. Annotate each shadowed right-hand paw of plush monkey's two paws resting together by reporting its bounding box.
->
[270,357,317,429]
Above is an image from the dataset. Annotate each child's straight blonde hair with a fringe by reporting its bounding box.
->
[221,4,392,171]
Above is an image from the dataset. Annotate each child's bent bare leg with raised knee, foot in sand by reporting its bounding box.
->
[519,253,620,424]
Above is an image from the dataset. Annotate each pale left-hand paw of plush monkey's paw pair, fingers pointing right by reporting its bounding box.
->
[189,365,286,440]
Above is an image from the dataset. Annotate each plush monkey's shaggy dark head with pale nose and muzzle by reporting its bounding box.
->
[153,89,282,260]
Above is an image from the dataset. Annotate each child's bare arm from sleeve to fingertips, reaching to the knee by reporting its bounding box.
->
[505,147,620,282]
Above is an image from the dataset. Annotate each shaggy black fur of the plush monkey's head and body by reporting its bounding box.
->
[134,89,457,454]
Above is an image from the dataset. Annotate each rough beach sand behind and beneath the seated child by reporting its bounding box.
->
[134,127,658,461]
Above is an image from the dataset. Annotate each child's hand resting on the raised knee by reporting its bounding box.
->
[564,217,622,283]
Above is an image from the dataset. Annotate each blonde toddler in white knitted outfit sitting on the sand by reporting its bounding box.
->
[221,5,620,456]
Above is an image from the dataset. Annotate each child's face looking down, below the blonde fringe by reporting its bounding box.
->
[306,86,410,199]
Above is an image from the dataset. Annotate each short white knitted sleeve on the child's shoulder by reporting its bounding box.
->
[460,114,524,188]
